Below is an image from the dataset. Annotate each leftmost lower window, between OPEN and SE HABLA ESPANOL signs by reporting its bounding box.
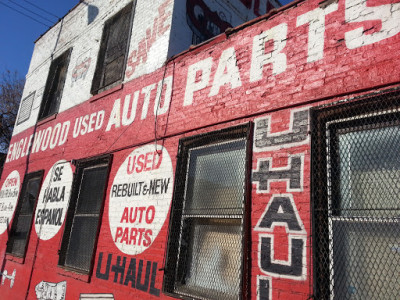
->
[6,171,43,257]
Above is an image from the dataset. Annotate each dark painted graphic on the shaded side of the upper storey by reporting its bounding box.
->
[186,0,233,42]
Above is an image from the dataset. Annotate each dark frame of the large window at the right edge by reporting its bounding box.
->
[311,90,400,299]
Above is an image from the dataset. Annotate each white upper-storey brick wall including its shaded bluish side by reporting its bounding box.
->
[13,0,277,135]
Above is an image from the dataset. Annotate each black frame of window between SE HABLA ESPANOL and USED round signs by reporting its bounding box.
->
[58,154,112,276]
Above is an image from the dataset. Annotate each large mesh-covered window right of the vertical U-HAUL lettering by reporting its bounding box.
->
[313,92,400,300]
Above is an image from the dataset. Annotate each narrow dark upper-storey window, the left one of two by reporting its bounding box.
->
[39,48,72,119]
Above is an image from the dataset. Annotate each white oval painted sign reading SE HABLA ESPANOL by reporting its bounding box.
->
[34,160,73,240]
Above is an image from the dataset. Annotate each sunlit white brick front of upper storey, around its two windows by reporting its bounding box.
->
[13,0,173,135]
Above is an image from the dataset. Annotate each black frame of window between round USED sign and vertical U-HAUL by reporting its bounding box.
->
[162,122,253,299]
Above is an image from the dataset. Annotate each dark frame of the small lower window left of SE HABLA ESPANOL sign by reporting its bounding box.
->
[6,170,44,259]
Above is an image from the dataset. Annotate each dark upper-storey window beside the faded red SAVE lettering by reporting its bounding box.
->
[91,2,136,95]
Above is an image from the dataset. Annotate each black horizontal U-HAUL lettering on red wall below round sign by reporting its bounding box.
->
[96,252,160,297]
